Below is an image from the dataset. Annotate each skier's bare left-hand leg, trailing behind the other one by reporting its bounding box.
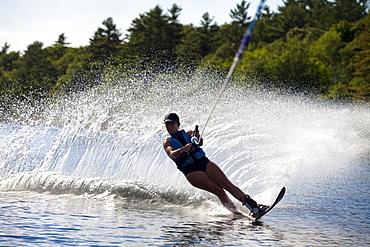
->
[186,171,240,214]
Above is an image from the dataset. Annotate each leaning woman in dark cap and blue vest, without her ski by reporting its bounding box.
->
[163,113,266,217]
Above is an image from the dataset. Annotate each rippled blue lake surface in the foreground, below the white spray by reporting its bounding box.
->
[0,165,370,246]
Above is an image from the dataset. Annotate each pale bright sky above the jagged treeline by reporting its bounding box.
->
[0,0,283,53]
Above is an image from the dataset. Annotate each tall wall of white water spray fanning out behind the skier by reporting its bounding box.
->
[0,70,370,205]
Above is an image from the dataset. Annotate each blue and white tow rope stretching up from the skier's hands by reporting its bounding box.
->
[201,0,266,136]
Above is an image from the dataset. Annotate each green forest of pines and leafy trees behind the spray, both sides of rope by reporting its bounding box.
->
[0,0,370,114]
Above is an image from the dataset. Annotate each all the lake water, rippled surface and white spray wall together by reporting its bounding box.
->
[0,71,370,246]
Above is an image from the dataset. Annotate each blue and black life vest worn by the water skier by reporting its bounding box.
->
[167,130,206,170]
